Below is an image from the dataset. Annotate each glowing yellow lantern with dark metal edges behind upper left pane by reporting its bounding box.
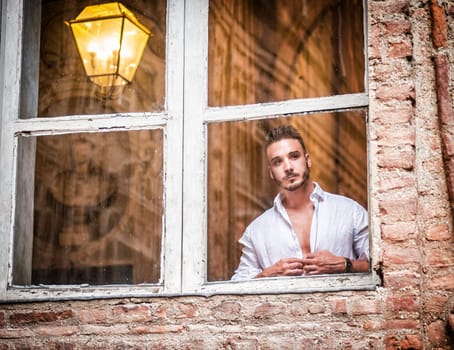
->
[65,2,152,91]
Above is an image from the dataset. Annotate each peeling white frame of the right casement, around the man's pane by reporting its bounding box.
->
[182,0,380,295]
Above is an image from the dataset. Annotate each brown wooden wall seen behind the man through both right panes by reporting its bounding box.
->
[208,0,367,280]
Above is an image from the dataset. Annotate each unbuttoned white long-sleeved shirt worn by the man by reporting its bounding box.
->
[232,182,369,280]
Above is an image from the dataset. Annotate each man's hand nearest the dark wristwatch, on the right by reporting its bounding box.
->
[303,250,345,275]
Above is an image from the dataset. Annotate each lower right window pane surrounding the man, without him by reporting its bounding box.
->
[208,111,367,281]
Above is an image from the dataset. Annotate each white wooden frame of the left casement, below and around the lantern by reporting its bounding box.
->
[0,0,184,302]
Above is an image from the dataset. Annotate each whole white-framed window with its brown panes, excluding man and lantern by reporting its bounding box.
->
[0,0,375,300]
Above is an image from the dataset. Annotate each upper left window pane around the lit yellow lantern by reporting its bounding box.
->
[21,0,166,118]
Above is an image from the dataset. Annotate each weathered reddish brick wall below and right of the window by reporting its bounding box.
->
[0,0,454,349]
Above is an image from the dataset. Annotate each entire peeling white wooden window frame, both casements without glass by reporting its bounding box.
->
[0,0,379,302]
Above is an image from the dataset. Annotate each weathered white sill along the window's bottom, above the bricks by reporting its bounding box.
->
[0,272,381,304]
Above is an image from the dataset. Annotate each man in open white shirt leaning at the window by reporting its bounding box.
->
[232,126,369,280]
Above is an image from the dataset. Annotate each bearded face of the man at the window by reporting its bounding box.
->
[266,139,311,191]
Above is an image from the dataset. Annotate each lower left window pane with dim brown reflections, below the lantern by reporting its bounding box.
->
[14,130,163,285]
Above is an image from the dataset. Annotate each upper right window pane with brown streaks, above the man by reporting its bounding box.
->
[208,0,364,106]
